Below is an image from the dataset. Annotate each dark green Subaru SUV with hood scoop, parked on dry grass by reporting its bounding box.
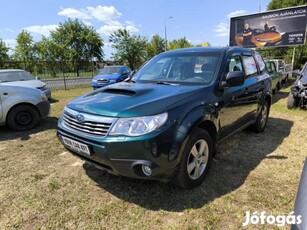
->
[57,47,271,188]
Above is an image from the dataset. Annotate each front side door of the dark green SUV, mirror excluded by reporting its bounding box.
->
[219,54,257,139]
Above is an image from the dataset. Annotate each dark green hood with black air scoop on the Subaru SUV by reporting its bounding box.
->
[67,82,205,117]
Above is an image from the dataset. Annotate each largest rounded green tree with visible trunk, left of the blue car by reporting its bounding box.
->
[51,19,104,76]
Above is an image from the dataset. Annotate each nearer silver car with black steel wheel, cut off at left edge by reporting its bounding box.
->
[0,84,50,131]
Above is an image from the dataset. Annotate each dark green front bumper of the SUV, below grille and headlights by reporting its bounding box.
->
[57,125,177,180]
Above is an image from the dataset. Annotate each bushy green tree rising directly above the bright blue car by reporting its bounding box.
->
[109,29,148,69]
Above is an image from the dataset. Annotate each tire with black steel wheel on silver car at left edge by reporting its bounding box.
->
[7,105,39,131]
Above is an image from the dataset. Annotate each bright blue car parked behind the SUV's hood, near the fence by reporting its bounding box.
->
[92,66,131,89]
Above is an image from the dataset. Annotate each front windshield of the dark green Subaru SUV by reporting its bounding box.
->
[133,52,220,84]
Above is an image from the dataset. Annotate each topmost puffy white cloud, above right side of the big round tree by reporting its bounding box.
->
[86,5,122,22]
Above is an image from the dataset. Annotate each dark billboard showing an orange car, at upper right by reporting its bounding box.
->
[229,5,307,48]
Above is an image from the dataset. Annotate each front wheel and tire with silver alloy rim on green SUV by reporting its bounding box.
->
[174,128,213,189]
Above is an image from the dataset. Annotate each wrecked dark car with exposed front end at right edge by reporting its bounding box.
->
[287,62,307,109]
